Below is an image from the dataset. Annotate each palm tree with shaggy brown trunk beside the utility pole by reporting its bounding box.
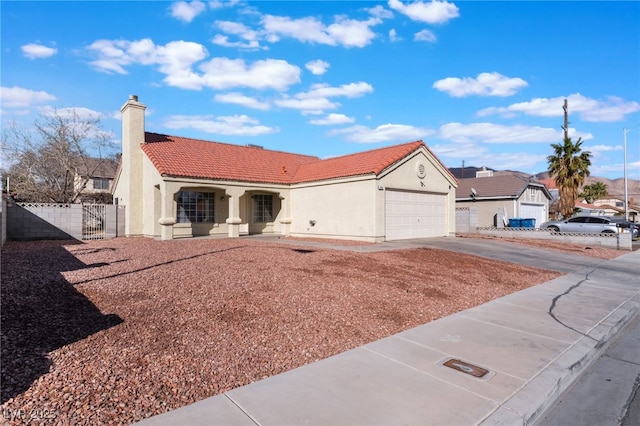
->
[547,136,591,218]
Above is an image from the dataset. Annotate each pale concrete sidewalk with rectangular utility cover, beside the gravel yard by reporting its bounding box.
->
[139,252,640,426]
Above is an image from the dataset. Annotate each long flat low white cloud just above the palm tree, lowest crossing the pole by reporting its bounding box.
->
[439,123,593,144]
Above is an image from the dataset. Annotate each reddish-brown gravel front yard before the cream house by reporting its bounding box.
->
[1,238,608,425]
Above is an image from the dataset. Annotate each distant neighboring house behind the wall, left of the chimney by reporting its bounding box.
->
[74,158,118,202]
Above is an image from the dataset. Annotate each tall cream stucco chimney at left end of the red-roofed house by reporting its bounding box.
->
[114,95,147,236]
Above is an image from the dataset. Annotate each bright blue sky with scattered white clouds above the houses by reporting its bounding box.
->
[0,0,640,179]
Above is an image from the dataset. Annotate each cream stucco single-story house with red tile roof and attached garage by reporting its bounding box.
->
[113,96,457,242]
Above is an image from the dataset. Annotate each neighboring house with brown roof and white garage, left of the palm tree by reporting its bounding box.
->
[456,171,551,228]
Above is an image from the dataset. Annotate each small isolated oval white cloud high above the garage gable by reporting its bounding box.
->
[433,72,528,98]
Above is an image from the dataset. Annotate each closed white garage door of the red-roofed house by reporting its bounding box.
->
[385,190,449,240]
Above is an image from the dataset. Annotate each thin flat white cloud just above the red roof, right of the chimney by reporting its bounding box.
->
[164,115,279,136]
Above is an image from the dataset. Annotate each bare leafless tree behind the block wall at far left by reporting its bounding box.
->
[2,109,113,203]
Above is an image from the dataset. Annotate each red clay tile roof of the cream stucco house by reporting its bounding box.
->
[142,132,436,184]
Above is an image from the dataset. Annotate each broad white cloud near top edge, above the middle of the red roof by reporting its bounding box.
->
[262,15,382,47]
